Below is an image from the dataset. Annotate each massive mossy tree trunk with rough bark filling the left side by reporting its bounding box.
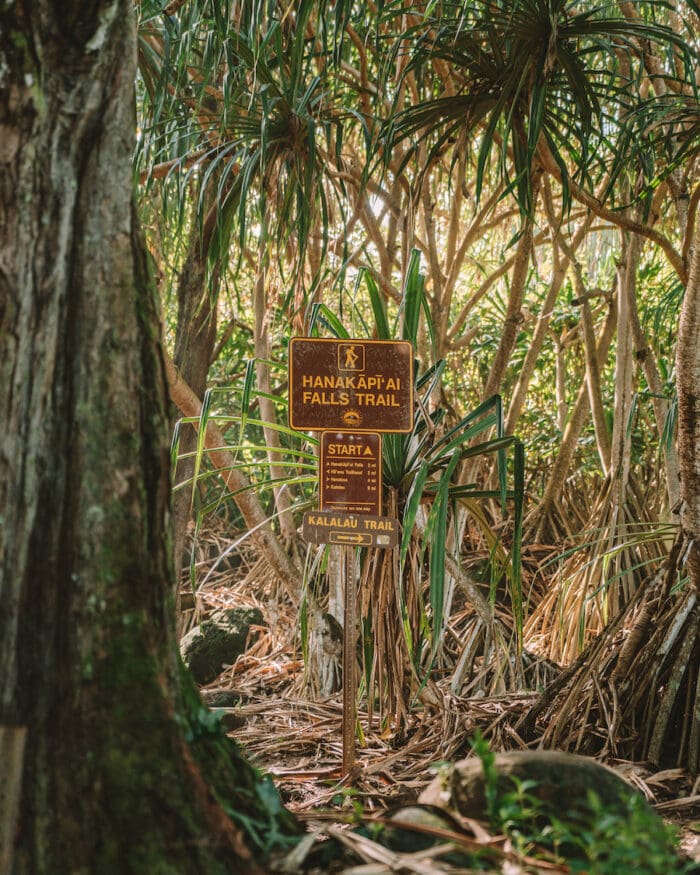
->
[0,0,293,875]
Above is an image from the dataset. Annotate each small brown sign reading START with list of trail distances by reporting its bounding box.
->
[319,431,382,516]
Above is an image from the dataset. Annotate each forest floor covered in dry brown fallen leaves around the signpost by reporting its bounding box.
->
[183,543,700,872]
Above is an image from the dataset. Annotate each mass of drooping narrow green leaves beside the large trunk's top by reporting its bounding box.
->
[137,0,358,280]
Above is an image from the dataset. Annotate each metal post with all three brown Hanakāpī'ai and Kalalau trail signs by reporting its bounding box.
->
[289,337,413,775]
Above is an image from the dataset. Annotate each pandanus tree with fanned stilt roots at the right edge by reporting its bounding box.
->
[498,4,700,771]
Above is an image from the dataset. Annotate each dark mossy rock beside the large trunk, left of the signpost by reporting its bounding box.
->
[180,608,263,684]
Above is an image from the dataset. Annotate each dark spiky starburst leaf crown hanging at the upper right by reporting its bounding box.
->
[386,0,687,212]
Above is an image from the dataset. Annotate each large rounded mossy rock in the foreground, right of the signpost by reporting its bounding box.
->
[419,750,656,821]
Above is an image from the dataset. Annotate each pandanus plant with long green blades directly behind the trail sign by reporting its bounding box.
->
[308,258,524,738]
